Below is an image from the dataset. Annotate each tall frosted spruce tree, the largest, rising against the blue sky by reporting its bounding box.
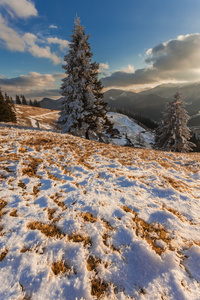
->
[58,17,112,138]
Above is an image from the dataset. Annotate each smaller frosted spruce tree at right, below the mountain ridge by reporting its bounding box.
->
[155,93,193,152]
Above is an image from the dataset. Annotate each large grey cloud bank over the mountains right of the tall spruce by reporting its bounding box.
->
[102,33,200,88]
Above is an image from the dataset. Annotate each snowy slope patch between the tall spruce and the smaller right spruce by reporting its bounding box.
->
[107,112,154,149]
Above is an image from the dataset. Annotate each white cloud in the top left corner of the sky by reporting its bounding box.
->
[0,0,38,18]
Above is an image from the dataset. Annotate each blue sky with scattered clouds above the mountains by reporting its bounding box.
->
[0,0,200,100]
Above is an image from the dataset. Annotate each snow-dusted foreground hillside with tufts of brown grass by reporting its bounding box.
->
[0,127,200,300]
